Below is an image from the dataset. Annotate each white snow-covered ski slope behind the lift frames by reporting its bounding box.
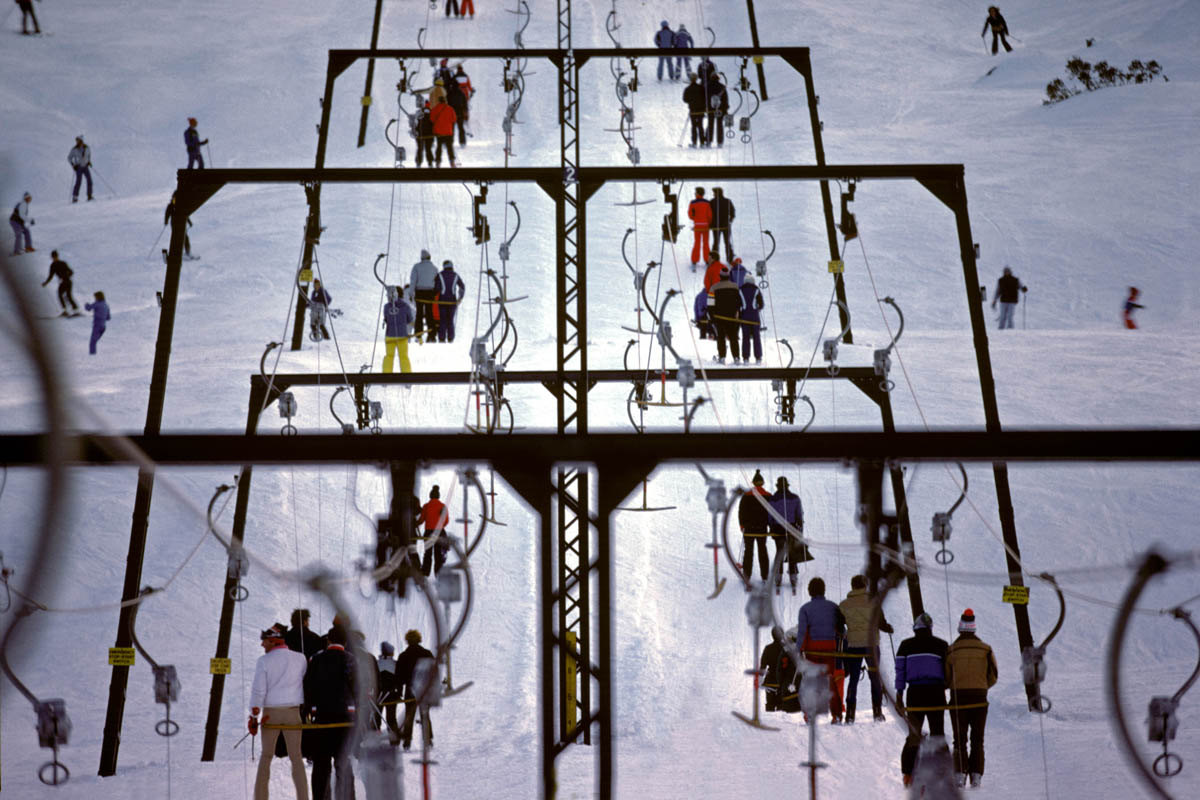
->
[0,0,1200,798]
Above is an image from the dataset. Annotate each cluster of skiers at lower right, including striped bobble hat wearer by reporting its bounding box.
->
[763,566,998,787]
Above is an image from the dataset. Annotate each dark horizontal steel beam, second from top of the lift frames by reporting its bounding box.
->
[176,164,962,188]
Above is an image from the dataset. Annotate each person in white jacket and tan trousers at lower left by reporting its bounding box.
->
[246,627,308,800]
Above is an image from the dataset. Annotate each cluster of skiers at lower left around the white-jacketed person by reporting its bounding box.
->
[246,608,437,800]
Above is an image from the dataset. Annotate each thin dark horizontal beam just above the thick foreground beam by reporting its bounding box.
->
[250,367,876,390]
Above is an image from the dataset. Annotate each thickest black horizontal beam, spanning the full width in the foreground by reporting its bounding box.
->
[0,428,1200,469]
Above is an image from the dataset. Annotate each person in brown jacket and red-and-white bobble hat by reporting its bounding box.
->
[946,608,1000,787]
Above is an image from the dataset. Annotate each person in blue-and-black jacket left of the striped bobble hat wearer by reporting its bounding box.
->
[895,613,949,786]
